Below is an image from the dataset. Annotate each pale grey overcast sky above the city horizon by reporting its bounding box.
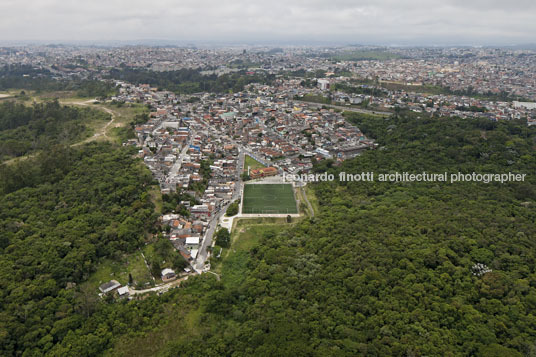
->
[0,0,536,45]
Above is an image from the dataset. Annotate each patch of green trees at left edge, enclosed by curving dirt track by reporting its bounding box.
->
[0,101,109,162]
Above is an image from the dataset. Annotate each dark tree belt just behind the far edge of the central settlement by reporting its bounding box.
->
[106,68,275,94]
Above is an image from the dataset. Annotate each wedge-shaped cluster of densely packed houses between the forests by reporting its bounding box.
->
[113,81,375,262]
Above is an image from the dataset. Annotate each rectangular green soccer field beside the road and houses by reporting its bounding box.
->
[242,184,298,214]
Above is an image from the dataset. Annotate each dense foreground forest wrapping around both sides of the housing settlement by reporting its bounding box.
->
[0,113,536,356]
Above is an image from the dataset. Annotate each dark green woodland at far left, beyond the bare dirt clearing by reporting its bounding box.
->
[0,65,117,98]
